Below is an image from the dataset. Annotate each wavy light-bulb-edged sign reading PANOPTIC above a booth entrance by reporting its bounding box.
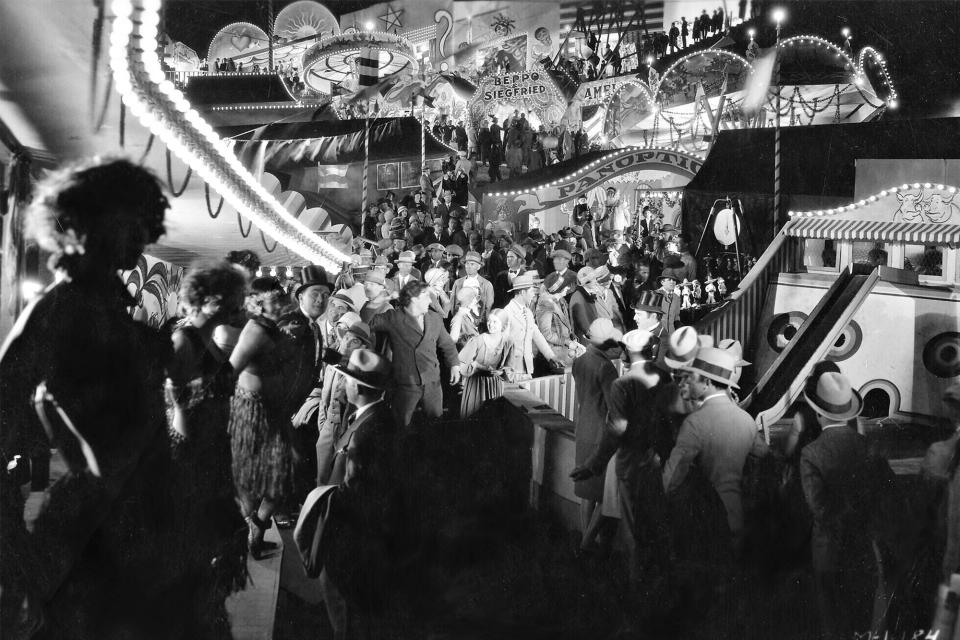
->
[481,149,703,220]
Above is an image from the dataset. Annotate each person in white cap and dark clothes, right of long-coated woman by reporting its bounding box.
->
[571,323,679,586]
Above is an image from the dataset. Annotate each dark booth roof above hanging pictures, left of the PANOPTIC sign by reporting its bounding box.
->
[217,117,457,164]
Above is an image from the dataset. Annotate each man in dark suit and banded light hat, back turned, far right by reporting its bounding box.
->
[800,372,876,640]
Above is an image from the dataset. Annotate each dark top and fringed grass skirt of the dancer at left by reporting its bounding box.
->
[228,317,294,501]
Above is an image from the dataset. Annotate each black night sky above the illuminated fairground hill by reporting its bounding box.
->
[164,0,960,117]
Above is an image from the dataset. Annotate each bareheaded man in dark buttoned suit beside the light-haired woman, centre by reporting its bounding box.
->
[370,281,460,426]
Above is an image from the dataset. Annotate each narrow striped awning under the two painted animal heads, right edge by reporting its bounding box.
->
[786,216,960,244]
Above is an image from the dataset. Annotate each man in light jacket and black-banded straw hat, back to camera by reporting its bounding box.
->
[663,347,757,552]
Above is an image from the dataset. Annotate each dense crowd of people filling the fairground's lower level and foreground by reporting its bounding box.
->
[0,160,960,638]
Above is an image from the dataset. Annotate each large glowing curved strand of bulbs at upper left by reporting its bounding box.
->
[110,0,350,271]
